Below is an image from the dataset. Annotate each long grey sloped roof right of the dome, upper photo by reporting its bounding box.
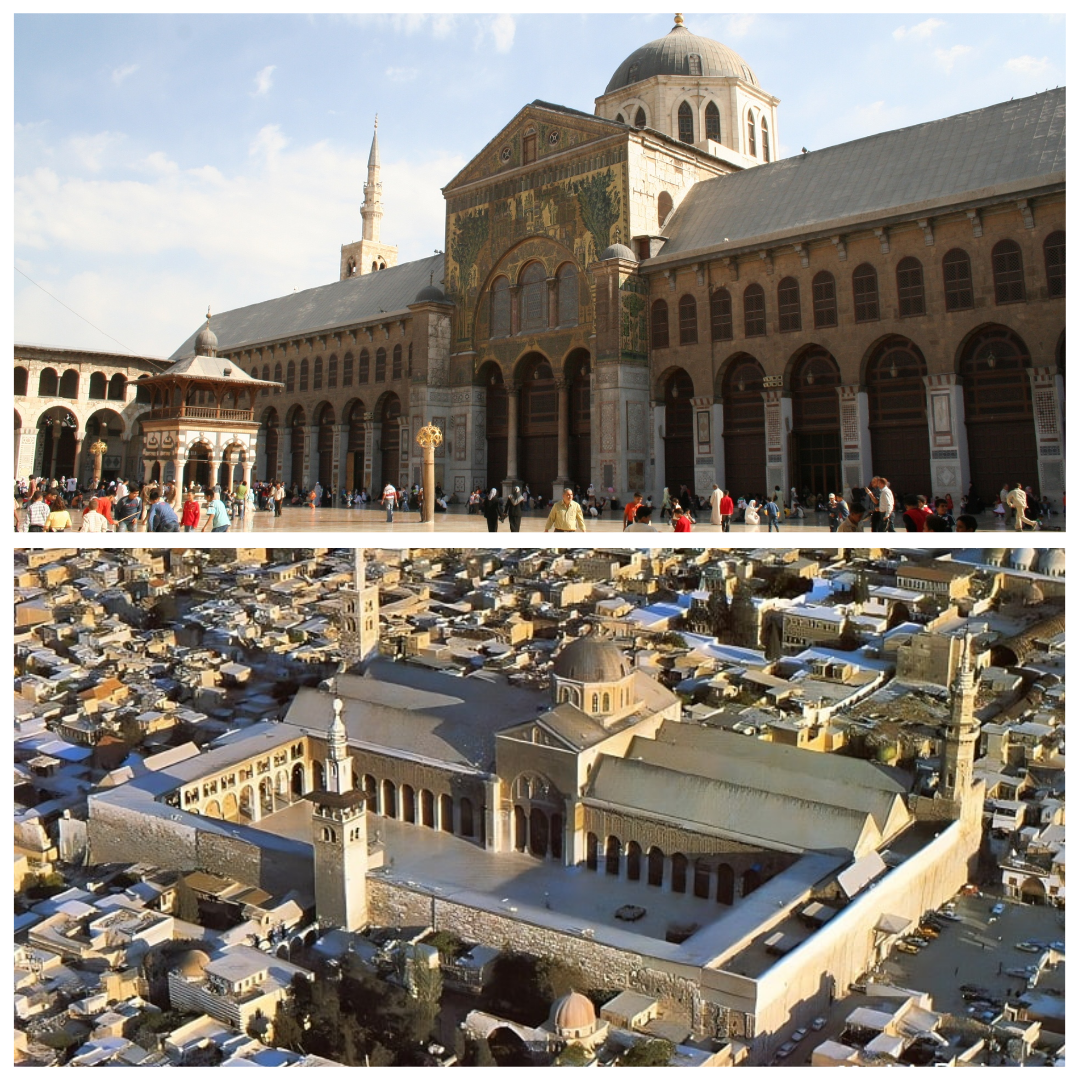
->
[645,86,1065,267]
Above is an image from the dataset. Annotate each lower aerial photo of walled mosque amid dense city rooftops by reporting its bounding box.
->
[14,538,1065,1067]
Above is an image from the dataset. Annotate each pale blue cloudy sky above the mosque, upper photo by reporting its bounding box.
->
[13,12,1065,356]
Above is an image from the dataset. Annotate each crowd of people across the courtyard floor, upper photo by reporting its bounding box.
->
[15,476,1065,532]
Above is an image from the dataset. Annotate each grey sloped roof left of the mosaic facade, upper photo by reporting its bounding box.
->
[170,255,443,360]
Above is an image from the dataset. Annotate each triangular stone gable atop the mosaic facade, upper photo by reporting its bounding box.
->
[443,102,629,195]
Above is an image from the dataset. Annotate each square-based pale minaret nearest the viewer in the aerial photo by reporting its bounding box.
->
[308,698,367,930]
